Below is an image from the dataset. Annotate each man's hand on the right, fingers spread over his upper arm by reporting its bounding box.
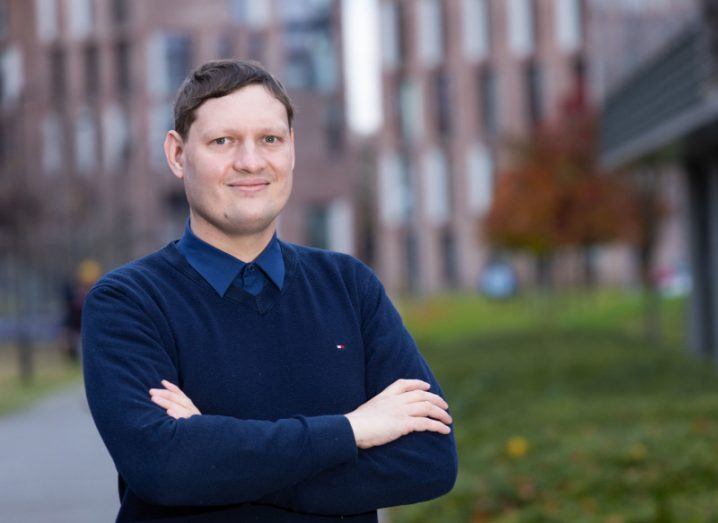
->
[346,379,452,449]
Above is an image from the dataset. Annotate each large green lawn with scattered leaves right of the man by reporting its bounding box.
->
[391,293,718,523]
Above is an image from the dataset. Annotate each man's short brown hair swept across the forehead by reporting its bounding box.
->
[174,59,294,140]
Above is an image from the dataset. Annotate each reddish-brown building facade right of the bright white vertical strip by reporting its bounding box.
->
[376,0,586,292]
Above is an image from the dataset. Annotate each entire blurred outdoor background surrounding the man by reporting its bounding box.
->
[0,0,718,523]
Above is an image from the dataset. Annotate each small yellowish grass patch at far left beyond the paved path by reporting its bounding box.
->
[0,345,82,416]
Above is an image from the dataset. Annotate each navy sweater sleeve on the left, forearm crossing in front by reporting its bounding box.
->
[82,284,357,506]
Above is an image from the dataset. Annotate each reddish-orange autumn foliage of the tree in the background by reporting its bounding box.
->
[484,95,635,256]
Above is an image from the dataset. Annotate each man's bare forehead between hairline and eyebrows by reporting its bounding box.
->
[190,84,289,134]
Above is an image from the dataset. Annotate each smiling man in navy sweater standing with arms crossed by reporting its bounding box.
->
[83,60,457,522]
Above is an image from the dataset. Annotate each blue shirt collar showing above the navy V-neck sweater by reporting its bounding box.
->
[177,218,284,296]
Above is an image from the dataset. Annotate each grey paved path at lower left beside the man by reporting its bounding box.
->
[0,386,119,523]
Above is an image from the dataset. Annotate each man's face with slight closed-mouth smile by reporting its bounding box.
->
[168,85,294,236]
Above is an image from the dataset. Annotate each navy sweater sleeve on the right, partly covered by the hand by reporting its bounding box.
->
[260,269,458,515]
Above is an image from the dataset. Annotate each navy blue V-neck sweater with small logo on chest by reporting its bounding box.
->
[82,242,457,522]
